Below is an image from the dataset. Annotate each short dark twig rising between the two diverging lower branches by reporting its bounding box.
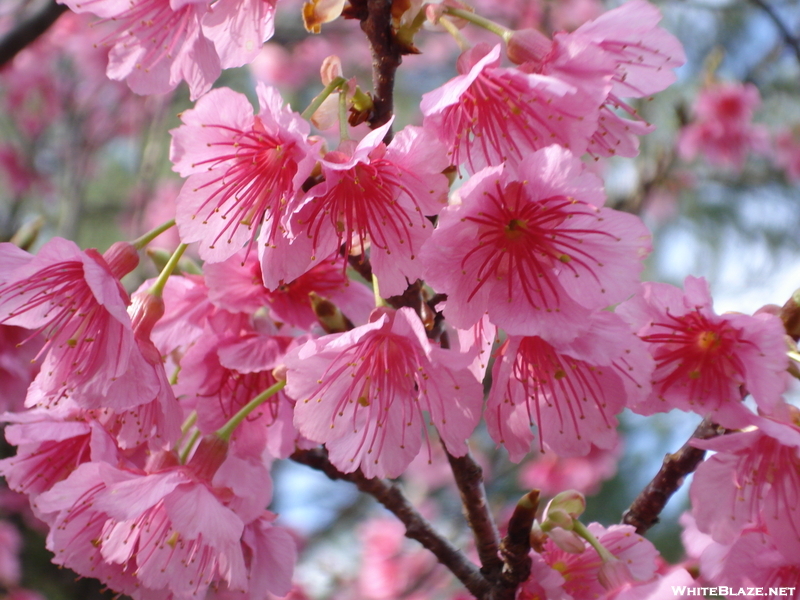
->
[445,449,503,581]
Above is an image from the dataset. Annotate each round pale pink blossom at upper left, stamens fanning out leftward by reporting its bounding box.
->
[170,84,315,264]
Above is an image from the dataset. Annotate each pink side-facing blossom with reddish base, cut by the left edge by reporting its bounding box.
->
[0,238,160,410]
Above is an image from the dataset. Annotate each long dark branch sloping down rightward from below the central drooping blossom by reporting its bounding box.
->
[291,449,491,599]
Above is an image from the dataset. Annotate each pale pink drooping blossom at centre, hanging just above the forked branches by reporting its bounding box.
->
[284,308,483,477]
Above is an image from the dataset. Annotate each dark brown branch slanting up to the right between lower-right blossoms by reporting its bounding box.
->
[622,418,727,535]
